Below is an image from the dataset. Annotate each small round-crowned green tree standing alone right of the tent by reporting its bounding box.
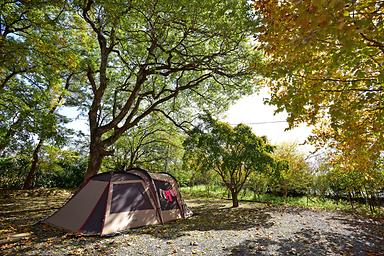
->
[184,117,273,207]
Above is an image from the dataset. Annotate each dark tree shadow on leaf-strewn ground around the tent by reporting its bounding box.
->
[0,193,273,255]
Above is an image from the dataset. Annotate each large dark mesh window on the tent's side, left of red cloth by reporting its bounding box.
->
[110,183,154,213]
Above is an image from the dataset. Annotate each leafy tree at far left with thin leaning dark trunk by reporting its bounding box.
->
[0,1,82,188]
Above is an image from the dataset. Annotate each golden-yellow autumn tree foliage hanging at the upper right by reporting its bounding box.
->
[254,0,384,171]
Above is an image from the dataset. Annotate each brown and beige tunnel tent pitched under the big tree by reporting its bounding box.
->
[44,168,191,235]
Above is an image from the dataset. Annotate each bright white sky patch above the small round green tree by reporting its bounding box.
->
[222,90,314,153]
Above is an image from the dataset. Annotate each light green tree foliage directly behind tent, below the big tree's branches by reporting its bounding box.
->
[103,113,183,176]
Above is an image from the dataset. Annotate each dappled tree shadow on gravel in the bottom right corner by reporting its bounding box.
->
[226,217,384,256]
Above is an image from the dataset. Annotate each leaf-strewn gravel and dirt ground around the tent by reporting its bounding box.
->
[0,190,384,255]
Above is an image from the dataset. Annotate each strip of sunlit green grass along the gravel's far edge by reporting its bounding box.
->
[181,185,384,217]
